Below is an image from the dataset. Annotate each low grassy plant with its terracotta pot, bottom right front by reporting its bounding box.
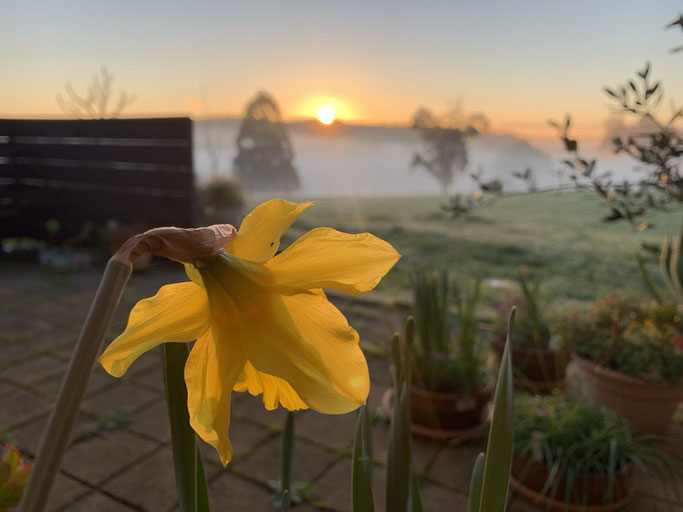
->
[510,391,680,512]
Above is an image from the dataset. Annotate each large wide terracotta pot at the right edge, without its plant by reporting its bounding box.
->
[572,353,683,434]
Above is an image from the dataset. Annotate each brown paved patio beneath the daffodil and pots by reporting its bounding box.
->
[0,263,681,512]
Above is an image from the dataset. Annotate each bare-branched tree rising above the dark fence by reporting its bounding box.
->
[57,66,135,119]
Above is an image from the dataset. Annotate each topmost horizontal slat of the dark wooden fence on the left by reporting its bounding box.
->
[0,117,192,140]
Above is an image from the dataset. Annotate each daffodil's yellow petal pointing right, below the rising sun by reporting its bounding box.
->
[265,228,401,295]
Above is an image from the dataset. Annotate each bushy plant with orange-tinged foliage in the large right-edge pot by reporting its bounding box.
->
[558,295,683,385]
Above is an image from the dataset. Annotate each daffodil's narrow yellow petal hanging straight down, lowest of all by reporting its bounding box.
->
[185,325,245,466]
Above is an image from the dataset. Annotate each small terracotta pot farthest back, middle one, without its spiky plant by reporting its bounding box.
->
[491,340,569,393]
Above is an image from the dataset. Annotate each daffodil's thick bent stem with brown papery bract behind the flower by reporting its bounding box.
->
[19,224,237,512]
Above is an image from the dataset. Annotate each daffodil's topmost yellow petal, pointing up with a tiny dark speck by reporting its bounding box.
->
[227,199,315,262]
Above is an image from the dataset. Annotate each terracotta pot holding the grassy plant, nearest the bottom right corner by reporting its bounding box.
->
[510,452,635,512]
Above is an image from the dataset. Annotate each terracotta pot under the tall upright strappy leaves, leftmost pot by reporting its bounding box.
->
[382,386,493,441]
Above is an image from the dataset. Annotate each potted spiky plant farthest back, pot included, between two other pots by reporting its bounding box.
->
[491,268,569,393]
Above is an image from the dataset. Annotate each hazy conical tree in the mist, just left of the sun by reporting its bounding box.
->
[234,92,300,192]
